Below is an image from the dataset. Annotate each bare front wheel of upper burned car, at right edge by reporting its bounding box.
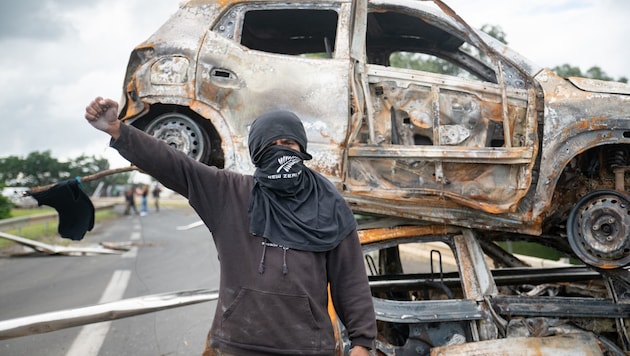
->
[567,190,630,269]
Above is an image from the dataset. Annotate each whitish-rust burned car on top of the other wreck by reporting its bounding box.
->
[120,0,630,268]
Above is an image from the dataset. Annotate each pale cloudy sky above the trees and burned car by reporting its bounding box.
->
[0,0,630,167]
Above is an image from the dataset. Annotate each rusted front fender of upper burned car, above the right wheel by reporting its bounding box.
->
[533,71,630,220]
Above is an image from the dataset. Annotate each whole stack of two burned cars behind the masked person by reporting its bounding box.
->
[120,0,630,355]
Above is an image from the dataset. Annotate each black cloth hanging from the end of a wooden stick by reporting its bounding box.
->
[31,179,94,240]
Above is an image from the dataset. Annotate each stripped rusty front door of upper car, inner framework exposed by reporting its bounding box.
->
[345,2,538,217]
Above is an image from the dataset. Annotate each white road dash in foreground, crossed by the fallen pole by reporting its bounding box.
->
[66,270,131,356]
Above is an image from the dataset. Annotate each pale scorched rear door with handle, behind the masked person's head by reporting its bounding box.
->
[196,1,350,181]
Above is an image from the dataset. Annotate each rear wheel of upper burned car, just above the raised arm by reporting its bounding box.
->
[145,113,209,161]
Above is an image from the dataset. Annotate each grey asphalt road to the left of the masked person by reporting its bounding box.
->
[0,207,219,356]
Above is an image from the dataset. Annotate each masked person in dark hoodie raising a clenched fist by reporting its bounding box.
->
[85,97,377,356]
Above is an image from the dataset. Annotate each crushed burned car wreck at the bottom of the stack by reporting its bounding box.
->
[360,226,630,355]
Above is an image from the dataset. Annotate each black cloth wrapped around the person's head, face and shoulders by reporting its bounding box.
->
[249,111,356,251]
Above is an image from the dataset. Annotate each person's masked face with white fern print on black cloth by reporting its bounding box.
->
[254,145,312,196]
